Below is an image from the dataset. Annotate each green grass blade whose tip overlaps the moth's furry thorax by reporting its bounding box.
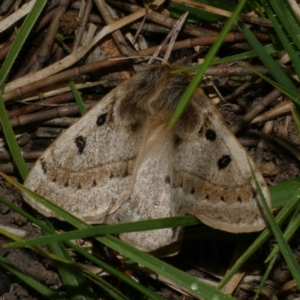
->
[169,0,246,127]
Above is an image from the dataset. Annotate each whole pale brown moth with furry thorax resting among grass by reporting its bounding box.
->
[24,66,271,252]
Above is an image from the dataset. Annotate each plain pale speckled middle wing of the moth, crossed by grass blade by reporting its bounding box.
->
[109,139,182,256]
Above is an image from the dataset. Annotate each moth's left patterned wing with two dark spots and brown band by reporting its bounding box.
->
[24,80,143,223]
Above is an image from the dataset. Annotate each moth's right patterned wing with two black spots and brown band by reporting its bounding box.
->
[172,90,271,232]
